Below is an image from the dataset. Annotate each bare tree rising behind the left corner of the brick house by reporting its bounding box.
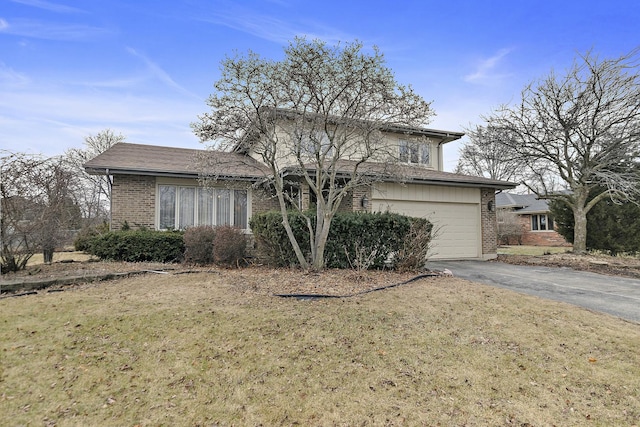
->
[65,129,125,222]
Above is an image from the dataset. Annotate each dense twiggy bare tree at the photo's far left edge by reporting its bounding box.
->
[0,151,80,271]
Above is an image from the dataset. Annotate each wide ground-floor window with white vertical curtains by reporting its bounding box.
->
[158,185,248,230]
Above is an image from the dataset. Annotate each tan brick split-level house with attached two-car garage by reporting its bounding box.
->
[84,121,516,259]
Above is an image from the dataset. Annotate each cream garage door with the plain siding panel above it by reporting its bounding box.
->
[371,184,482,259]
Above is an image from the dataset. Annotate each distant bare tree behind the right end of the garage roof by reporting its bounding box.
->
[456,126,523,182]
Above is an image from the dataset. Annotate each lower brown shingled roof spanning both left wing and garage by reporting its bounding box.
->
[84,143,517,190]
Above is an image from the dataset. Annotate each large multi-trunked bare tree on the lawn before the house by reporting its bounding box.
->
[193,38,433,269]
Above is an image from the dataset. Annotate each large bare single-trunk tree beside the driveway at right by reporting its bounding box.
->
[487,49,640,253]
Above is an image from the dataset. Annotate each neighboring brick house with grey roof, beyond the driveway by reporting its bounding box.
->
[496,192,569,246]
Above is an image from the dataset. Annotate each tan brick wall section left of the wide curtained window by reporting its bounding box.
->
[111,175,156,230]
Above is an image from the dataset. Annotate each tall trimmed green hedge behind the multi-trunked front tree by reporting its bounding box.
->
[251,212,430,269]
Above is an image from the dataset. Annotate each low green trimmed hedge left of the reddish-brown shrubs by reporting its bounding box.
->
[89,230,184,262]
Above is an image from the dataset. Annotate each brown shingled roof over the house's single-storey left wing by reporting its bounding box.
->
[84,143,268,180]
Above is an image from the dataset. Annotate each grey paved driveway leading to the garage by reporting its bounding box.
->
[427,261,640,323]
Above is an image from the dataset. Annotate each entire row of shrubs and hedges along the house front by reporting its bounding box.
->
[76,212,431,270]
